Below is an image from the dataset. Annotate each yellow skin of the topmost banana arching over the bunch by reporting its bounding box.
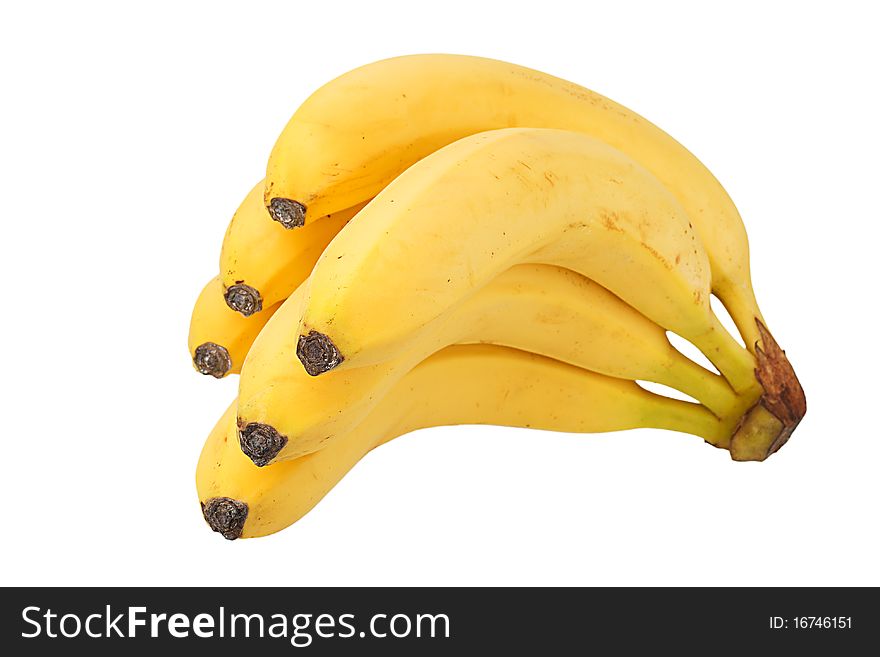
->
[264,54,763,349]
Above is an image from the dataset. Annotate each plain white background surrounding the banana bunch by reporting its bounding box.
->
[0,0,880,585]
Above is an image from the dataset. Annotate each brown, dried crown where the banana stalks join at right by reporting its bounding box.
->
[730,319,807,461]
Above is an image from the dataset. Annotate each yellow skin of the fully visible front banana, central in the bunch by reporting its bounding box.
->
[298,128,756,394]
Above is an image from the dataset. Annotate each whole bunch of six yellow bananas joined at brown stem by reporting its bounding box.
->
[189,55,806,539]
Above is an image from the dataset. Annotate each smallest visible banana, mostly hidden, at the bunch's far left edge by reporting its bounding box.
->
[189,276,281,379]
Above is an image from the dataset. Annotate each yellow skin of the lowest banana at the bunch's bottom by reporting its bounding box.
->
[196,345,729,538]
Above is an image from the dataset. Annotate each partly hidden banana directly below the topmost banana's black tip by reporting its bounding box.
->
[220,181,363,316]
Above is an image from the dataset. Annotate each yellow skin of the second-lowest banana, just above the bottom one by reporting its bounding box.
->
[236,265,750,469]
